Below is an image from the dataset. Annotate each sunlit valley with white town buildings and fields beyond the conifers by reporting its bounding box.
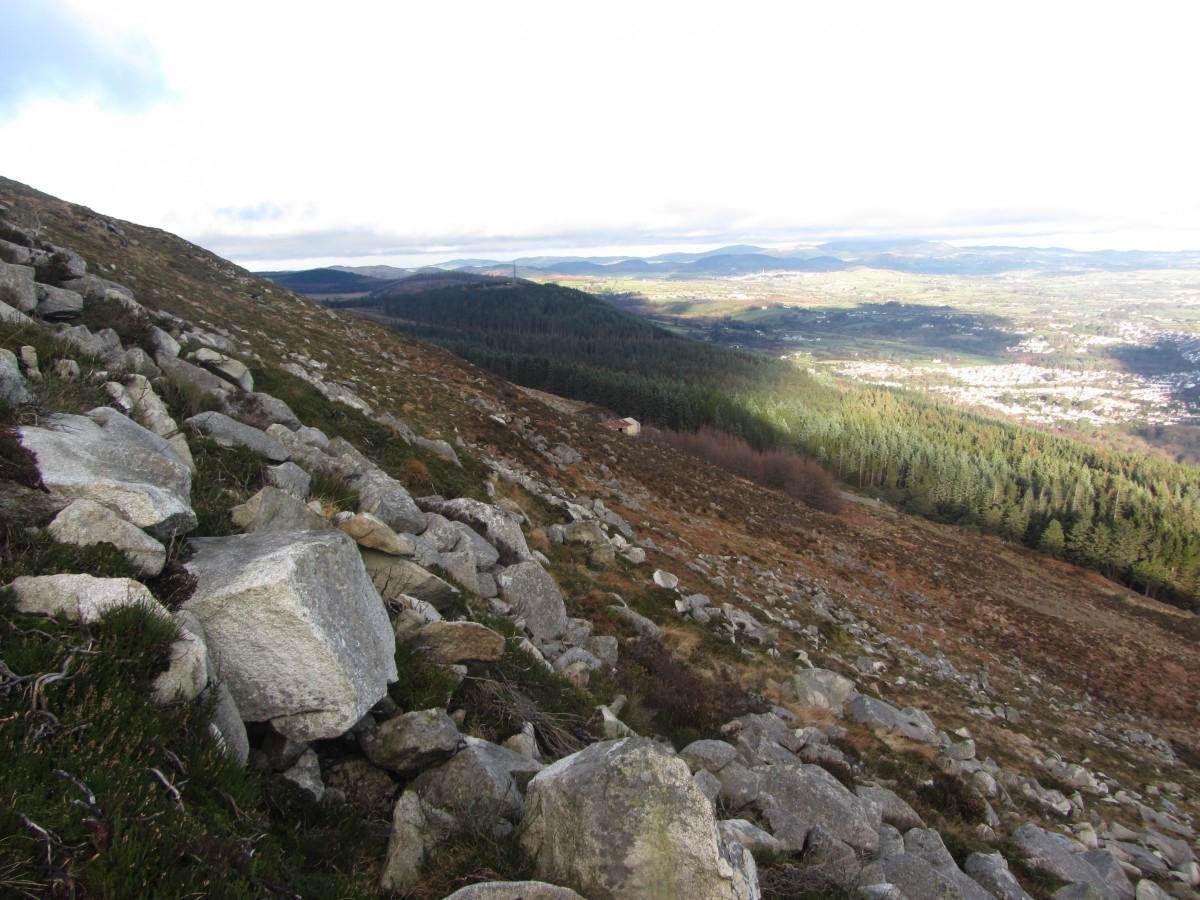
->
[554,268,1200,430]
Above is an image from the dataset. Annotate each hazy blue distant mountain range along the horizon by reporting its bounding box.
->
[258,240,1200,298]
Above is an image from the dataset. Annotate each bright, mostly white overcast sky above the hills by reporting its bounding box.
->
[0,0,1200,270]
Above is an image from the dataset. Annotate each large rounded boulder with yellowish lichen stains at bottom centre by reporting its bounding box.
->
[521,738,757,900]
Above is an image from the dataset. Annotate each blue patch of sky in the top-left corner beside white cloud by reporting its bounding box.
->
[0,0,172,122]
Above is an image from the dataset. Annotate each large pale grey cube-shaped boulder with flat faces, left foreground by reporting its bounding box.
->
[185,530,396,740]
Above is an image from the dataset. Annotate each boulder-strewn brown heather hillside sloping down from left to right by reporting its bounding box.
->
[0,180,1200,900]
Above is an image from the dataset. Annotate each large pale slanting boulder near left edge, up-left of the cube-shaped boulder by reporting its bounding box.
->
[18,407,196,540]
